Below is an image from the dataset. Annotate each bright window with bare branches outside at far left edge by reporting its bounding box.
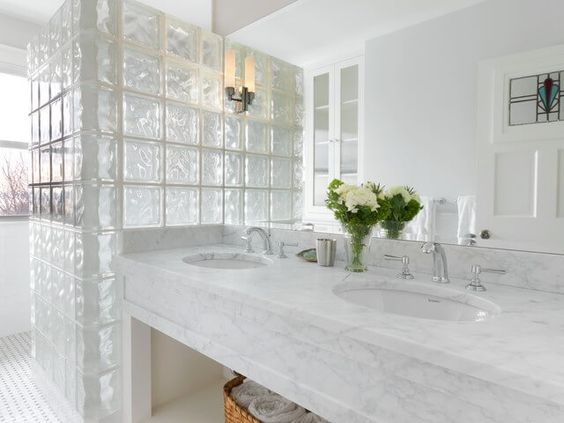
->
[0,73,30,217]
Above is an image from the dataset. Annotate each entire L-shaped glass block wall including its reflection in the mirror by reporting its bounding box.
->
[28,0,303,422]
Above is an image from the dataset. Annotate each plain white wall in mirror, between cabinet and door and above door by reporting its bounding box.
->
[364,0,564,199]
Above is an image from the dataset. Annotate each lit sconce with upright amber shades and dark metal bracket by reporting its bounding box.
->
[225,50,255,113]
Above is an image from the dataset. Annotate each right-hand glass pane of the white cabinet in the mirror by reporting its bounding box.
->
[338,65,359,184]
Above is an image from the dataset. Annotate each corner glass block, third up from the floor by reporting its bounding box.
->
[76,278,121,326]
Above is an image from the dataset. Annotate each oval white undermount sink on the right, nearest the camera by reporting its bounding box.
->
[334,282,501,322]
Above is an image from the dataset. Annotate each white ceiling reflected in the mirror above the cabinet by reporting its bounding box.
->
[229,0,490,66]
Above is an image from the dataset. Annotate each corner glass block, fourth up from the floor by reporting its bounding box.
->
[73,232,116,279]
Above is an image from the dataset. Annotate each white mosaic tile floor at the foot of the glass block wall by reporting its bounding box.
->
[0,333,61,423]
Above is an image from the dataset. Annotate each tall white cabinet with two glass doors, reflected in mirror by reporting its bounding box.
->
[305,56,364,222]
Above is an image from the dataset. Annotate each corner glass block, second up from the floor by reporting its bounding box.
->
[76,324,121,374]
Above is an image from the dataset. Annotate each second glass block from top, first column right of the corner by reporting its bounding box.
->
[123,47,161,95]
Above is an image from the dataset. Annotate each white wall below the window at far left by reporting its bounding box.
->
[0,220,31,337]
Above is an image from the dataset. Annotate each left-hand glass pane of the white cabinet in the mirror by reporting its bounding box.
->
[313,72,333,206]
